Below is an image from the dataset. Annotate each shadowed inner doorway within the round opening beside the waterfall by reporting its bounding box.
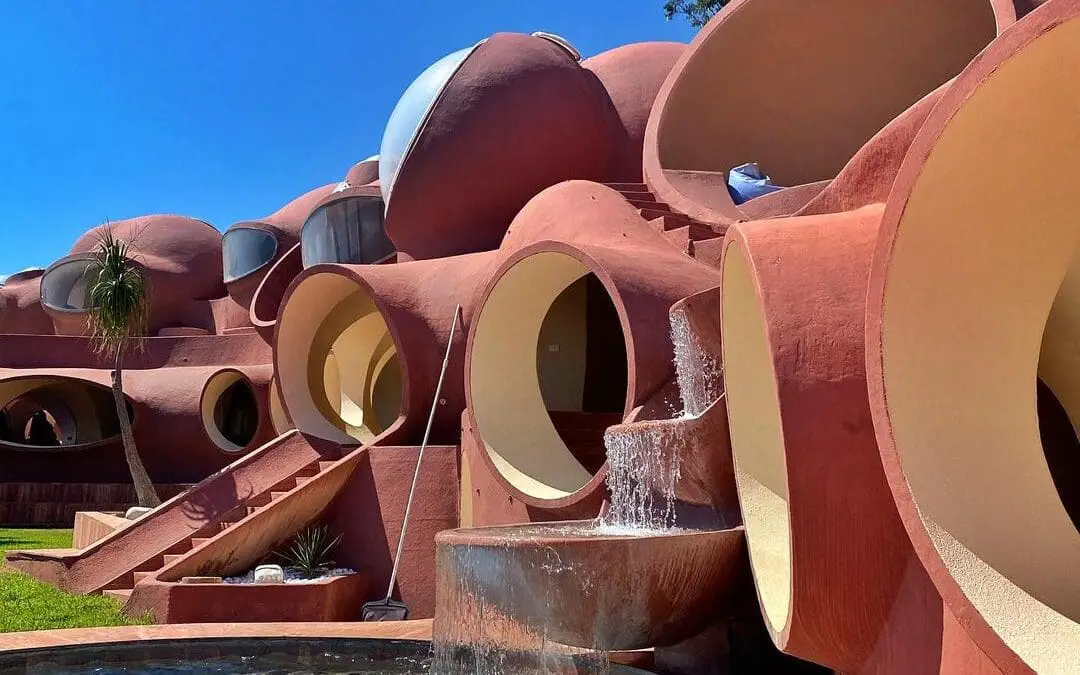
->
[537,273,627,473]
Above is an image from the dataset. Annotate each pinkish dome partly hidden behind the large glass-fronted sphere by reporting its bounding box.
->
[581,42,687,183]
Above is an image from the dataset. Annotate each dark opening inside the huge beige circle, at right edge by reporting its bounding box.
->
[1036,379,1080,529]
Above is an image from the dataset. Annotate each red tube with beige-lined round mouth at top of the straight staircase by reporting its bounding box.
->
[274,254,492,444]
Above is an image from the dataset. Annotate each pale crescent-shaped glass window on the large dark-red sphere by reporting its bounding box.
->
[377,43,480,202]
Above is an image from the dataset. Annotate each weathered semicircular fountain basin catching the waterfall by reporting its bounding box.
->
[435,521,748,651]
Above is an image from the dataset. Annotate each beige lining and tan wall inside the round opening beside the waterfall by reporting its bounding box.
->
[469,252,626,499]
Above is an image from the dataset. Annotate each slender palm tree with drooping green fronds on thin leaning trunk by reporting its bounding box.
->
[86,222,161,508]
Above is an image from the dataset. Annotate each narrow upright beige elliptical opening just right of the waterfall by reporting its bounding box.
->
[720,241,792,632]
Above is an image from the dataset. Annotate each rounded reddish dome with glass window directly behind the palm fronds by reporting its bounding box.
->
[47,215,225,335]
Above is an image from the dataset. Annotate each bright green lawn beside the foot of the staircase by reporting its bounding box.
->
[0,529,146,633]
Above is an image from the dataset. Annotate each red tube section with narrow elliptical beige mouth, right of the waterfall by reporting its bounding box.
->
[720,205,910,672]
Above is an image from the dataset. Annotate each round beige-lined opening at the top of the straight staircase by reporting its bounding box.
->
[278,273,404,443]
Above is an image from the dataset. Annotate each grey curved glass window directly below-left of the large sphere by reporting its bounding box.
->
[300,197,394,268]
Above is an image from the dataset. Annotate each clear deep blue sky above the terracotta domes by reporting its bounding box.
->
[0,0,693,272]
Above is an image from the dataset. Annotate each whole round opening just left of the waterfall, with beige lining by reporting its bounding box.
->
[469,252,629,500]
